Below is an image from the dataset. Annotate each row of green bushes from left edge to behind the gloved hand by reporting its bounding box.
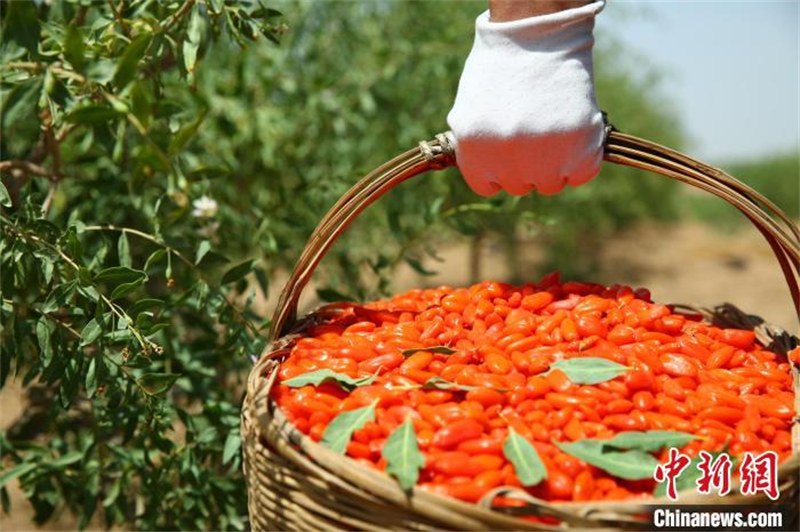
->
[0,0,678,530]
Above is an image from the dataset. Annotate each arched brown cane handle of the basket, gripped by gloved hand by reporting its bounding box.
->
[269,128,800,341]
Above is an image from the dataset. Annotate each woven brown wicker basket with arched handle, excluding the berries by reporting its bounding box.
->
[242,130,800,530]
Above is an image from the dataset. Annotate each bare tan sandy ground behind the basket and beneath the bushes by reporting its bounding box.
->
[0,223,798,531]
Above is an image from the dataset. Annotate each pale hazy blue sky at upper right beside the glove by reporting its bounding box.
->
[597,0,800,163]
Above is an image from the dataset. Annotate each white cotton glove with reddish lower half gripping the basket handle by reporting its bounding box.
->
[447,0,605,196]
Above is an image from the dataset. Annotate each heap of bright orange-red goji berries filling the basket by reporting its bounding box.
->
[273,274,794,501]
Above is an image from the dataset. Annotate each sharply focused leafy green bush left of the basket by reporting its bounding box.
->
[0,1,283,529]
